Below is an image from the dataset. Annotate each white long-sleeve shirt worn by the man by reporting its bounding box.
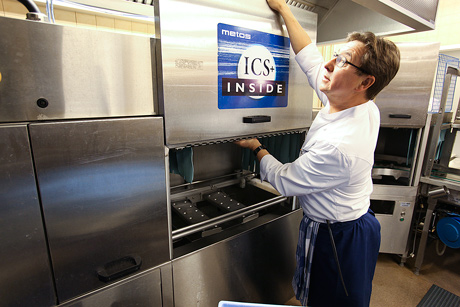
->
[260,44,380,222]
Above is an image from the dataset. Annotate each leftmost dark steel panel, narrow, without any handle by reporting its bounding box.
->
[0,125,56,306]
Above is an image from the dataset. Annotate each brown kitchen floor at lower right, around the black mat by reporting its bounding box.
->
[286,241,460,307]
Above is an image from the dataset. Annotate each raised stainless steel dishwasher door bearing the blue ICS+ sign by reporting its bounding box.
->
[156,0,317,147]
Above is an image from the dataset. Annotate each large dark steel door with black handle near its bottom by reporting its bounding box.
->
[30,117,169,302]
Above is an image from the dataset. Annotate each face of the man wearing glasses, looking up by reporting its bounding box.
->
[319,41,366,101]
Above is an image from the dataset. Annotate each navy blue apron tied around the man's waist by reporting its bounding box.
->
[308,213,380,307]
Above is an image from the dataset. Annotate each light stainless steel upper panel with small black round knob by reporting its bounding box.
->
[0,17,157,122]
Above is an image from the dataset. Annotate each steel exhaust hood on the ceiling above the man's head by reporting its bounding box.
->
[292,0,439,43]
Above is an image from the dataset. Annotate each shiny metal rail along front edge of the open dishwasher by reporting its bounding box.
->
[172,196,287,241]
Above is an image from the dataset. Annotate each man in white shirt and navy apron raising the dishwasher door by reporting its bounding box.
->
[237,0,400,306]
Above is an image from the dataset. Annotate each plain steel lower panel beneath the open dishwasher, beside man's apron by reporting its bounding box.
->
[172,210,302,307]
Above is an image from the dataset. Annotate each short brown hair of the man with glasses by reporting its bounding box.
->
[347,32,401,99]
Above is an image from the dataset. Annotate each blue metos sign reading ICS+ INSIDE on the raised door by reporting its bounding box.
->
[217,23,290,109]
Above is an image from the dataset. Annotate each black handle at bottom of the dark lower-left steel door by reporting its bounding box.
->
[97,256,142,282]
